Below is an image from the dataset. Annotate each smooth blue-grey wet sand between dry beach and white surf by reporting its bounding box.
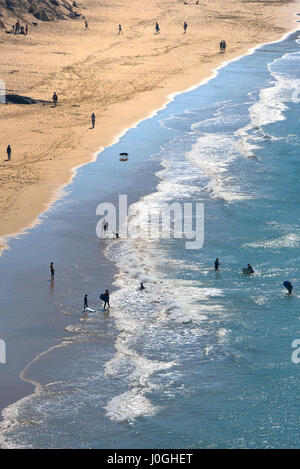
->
[0,114,159,436]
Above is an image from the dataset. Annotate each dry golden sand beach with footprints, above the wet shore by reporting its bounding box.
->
[0,0,300,249]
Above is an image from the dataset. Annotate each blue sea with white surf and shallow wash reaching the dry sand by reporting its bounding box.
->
[1,32,300,448]
